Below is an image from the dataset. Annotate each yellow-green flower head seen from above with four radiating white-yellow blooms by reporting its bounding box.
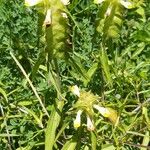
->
[71,85,118,131]
